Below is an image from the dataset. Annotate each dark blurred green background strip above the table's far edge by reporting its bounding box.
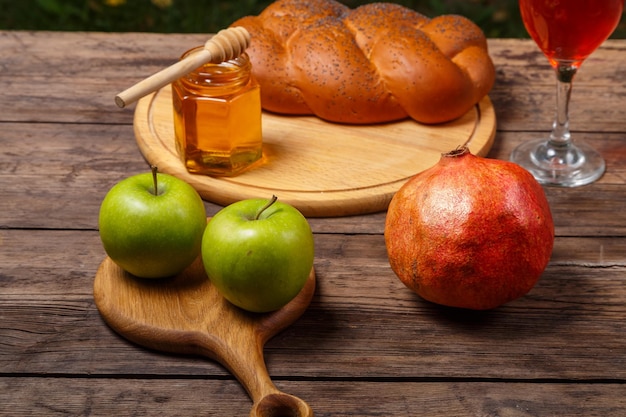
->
[0,0,626,39]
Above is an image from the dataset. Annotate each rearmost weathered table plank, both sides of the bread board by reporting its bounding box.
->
[0,31,626,132]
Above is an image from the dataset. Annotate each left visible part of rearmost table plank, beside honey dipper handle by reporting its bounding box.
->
[0,31,207,125]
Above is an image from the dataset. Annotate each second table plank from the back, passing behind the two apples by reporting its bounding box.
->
[0,123,626,232]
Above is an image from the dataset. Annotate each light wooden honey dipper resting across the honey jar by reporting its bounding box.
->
[115,26,250,107]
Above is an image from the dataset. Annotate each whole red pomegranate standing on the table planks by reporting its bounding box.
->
[385,147,554,310]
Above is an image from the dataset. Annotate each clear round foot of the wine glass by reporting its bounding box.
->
[510,139,606,187]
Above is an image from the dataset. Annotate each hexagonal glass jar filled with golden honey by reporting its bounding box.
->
[172,46,262,176]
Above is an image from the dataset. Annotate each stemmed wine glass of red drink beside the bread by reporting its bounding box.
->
[511,0,624,187]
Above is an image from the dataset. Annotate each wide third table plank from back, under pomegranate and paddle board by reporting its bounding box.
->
[0,230,626,380]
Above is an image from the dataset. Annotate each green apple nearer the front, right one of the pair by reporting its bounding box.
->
[202,197,314,313]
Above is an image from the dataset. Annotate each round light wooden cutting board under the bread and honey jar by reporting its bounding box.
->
[134,86,496,217]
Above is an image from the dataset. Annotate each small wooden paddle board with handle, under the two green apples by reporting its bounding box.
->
[94,257,315,417]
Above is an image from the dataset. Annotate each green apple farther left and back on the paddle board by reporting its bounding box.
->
[99,167,207,278]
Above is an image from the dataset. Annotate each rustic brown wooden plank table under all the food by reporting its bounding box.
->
[0,32,626,417]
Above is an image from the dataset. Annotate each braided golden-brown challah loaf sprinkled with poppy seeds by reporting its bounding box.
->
[232,0,495,124]
